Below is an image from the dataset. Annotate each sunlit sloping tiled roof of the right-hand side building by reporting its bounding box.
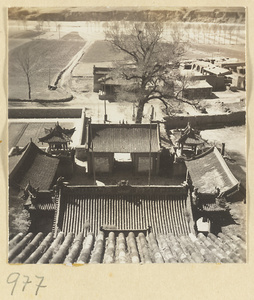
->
[185,147,239,193]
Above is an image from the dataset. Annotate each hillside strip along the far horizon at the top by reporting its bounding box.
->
[8,7,245,24]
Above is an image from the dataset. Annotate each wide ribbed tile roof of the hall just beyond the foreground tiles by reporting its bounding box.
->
[56,187,192,235]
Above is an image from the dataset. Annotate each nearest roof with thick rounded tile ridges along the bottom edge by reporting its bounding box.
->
[8,231,246,264]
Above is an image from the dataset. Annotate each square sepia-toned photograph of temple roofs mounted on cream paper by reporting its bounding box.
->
[7,6,246,264]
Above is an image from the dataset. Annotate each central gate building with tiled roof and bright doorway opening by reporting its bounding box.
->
[88,124,161,174]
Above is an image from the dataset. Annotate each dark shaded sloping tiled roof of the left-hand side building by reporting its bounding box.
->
[9,142,59,190]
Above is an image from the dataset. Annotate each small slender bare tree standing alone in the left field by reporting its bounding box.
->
[14,47,38,100]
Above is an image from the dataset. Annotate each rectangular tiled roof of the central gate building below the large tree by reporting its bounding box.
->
[90,124,160,153]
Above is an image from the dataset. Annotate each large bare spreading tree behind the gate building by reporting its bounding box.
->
[105,23,192,123]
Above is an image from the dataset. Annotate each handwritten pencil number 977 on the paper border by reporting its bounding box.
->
[7,273,47,296]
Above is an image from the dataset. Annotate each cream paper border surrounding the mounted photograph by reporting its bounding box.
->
[0,0,254,300]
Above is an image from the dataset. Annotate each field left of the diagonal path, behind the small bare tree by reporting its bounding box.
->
[9,33,85,99]
